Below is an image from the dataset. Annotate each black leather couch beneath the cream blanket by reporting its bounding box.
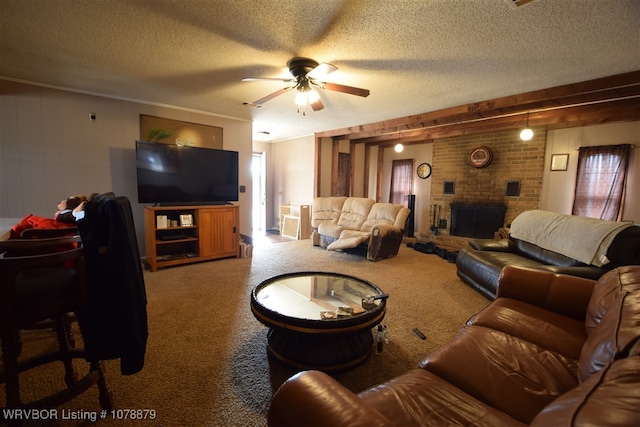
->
[456,222,640,300]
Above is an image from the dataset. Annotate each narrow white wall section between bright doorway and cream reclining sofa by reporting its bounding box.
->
[267,135,315,228]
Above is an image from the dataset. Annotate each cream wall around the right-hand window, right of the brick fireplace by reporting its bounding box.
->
[540,122,640,223]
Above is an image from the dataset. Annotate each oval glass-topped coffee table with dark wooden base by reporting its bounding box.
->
[251,272,386,371]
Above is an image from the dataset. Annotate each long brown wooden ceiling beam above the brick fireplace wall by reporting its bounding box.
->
[316,71,640,143]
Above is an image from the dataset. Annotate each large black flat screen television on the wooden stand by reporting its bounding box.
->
[136,141,238,205]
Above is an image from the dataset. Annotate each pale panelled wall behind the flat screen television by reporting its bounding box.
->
[0,80,252,253]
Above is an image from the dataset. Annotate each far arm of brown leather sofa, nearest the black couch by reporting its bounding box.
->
[496,265,595,321]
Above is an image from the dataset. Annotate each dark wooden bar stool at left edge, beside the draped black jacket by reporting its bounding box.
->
[0,235,112,416]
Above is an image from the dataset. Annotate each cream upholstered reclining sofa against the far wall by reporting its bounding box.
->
[311,197,410,261]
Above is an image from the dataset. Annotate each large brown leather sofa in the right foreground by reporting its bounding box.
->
[268,266,640,427]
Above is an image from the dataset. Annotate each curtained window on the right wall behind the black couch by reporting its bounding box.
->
[572,145,631,221]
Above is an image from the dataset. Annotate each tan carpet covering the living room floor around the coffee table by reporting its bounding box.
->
[0,240,488,426]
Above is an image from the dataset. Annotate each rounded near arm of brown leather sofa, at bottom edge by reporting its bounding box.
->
[267,371,392,427]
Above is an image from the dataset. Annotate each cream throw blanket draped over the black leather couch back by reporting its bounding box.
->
[510,210,632,267]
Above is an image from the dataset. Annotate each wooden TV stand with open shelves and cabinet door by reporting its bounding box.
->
[144,205,239,271]
